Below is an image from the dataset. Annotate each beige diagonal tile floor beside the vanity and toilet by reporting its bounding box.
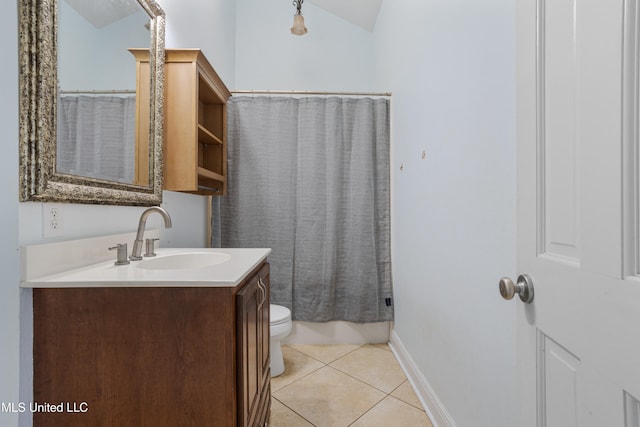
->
[269,344,433,427]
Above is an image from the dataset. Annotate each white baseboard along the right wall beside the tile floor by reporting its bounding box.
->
[389,330,456,427]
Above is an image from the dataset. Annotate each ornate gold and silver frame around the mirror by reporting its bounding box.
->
[18,0,165,206]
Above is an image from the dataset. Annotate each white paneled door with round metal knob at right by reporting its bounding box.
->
[509,0,640,427]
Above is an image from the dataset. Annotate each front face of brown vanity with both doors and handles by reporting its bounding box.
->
[236,264,271,426]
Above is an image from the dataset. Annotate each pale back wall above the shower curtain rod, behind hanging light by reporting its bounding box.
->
[234,0,374,91]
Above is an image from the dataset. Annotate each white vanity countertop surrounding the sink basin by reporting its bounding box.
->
[21,248,271,288]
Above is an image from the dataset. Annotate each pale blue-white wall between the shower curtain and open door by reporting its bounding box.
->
[375,0,517,427]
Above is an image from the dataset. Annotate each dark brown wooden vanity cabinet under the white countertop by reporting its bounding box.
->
[27,262,271,427]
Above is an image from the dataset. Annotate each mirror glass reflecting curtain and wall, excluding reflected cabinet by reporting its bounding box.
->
[56,0,151,185]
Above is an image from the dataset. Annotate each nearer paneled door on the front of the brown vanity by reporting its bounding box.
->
[236,274,268,426]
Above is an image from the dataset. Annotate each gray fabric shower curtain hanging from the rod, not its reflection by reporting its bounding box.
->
[214,96,393,323]
